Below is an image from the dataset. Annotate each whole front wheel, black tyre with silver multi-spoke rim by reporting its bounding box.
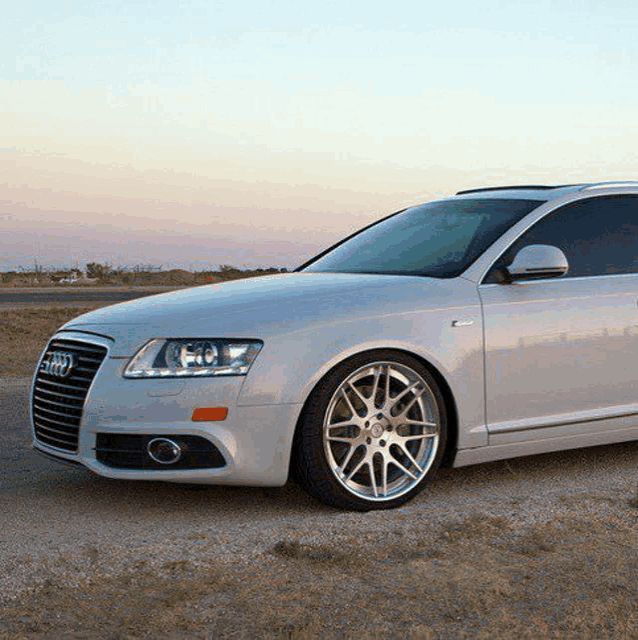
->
[296,351,446,510]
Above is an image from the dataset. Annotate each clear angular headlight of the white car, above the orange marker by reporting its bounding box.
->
[124,338,264,378]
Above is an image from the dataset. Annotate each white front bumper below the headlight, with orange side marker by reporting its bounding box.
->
[32,333,301,486]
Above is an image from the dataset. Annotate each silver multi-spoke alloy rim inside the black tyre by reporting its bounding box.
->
[323,362,440,501]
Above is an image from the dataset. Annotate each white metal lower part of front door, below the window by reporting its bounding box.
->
[480,275,638,444]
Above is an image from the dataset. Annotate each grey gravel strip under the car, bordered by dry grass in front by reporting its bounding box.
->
[0,378,638,599]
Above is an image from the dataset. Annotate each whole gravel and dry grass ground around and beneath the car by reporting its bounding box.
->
[0,308,638,640]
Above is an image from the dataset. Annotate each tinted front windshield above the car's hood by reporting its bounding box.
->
[301,198,543,278]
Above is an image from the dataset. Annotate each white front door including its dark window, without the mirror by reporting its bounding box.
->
[479,196,638,444]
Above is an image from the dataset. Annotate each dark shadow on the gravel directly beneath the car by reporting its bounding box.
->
[8,442,638,517]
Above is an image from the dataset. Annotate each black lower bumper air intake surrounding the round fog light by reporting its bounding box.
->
[95,433,226,471]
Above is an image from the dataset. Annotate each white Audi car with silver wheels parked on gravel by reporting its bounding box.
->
[31,182,638,510]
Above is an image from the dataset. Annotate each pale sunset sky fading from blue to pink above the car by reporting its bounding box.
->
[0,0,638,271]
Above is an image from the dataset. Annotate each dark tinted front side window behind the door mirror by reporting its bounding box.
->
[483,195,638,284]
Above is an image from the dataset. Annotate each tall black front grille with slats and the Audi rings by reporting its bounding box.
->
[31,339,107,453]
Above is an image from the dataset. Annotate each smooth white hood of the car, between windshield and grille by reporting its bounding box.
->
[62,273,470,357]
